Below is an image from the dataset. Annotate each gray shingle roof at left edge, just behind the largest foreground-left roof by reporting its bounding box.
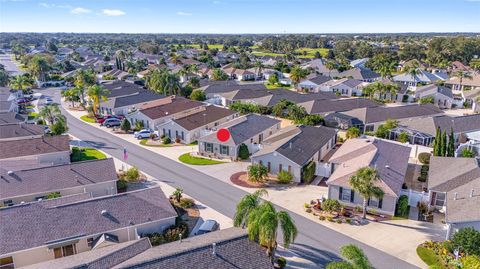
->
[0,158,117,199]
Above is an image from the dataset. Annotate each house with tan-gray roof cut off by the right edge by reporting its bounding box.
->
[428,156,480,239]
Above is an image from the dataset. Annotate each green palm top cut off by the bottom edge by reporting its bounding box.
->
[327,244,372,269]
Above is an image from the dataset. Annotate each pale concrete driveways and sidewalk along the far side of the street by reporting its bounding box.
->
[62,103,445,268]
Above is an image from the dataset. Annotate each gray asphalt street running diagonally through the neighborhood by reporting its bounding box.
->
[46,90,418,269]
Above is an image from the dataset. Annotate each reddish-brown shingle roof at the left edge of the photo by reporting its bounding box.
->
[0,135,70,159]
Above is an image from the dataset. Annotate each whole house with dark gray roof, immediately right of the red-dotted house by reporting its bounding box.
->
[251,125,337,182]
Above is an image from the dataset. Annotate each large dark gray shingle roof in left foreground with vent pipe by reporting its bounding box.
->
[0,187,177,255]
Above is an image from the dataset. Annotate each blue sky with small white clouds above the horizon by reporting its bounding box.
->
[0,0,480,33]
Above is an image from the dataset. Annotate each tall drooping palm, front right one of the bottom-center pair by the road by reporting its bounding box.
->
[247,201,298,258]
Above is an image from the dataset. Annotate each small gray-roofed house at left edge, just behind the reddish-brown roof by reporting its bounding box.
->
[0,123,45,141]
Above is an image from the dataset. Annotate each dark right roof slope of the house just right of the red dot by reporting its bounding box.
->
[268,126,337,166]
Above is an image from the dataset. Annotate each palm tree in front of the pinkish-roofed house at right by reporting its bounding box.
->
[349,166,385,219]
